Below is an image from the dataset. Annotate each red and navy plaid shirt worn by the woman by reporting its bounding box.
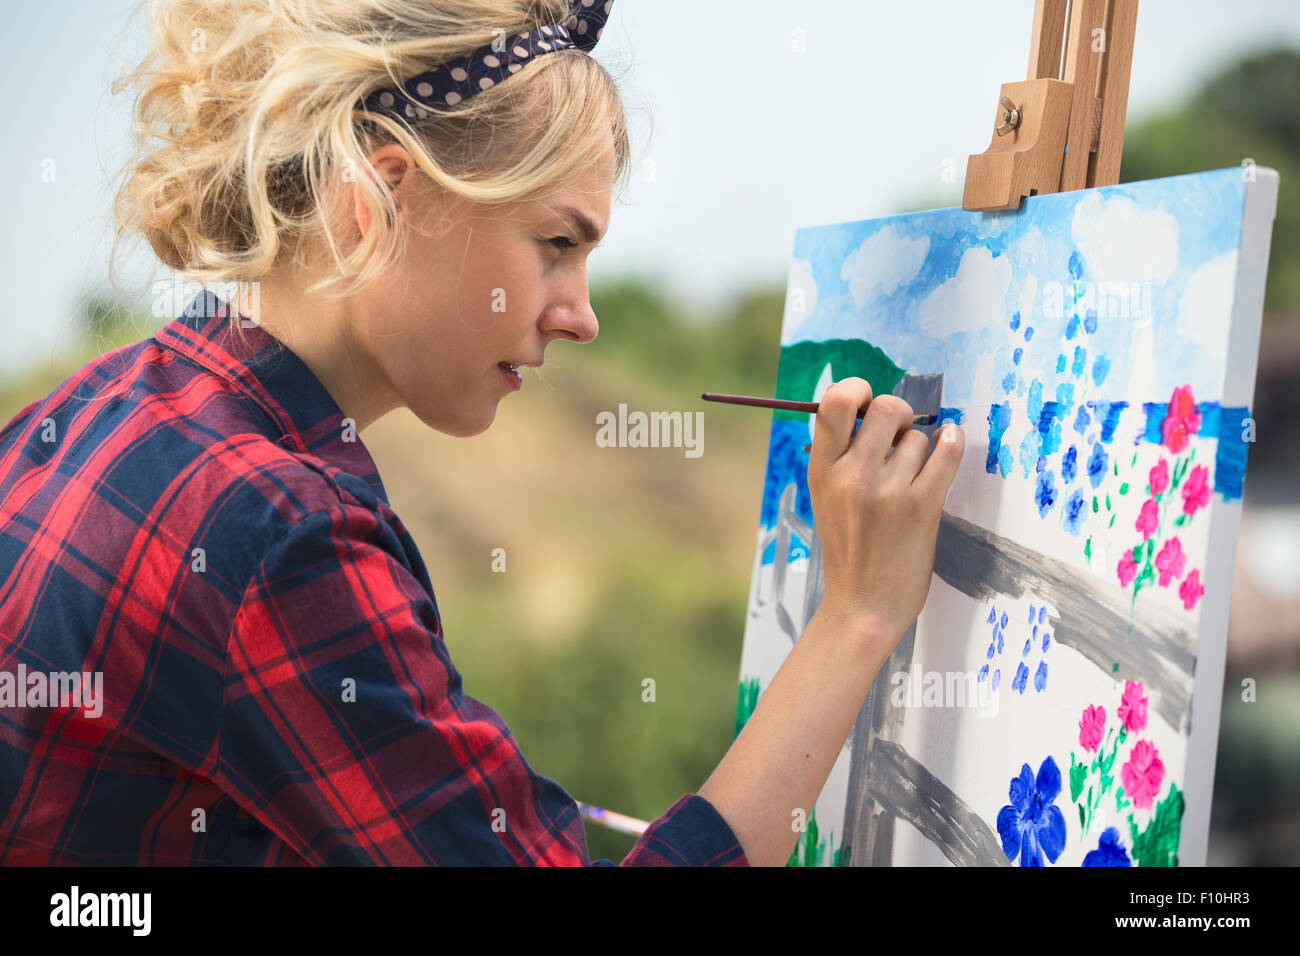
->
[0,290,748,866]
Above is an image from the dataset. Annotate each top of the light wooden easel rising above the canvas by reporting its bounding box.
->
[962,0,1138,211]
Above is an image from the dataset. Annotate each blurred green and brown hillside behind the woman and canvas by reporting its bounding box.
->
[0,51,1300,864]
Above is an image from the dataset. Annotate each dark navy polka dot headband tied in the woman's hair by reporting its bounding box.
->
[361,0,614,125]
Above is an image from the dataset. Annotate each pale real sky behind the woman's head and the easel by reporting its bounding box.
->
[0,0,1300,375]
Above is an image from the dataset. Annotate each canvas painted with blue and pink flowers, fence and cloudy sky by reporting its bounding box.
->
[736,166,1278,866]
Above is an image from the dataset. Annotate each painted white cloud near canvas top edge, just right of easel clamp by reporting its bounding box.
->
[1070,193,1178,282]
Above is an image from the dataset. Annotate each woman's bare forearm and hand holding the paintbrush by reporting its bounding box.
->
[699,378,965,866]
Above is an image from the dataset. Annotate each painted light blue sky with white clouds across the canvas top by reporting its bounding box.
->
[783,168,1245,407]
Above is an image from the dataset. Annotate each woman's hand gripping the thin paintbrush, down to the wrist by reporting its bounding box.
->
[807,378,966,648]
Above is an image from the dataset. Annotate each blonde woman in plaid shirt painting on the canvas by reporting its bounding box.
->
[0,0,962,865]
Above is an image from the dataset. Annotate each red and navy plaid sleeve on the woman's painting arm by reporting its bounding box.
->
[215,502,744,865]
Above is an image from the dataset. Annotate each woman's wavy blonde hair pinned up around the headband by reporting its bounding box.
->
[112,0,629,328]
